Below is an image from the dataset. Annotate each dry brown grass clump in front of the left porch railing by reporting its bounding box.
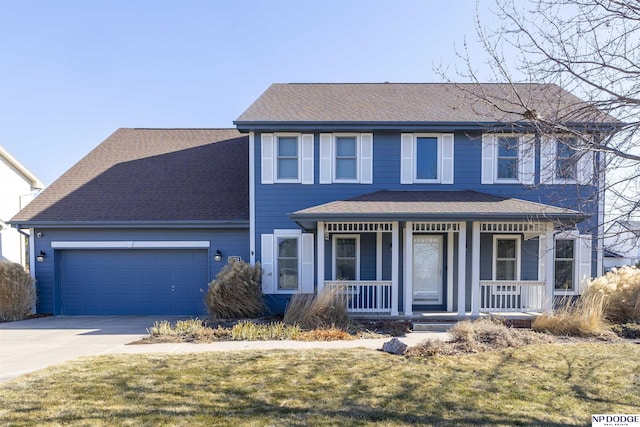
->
[283,289,350,330]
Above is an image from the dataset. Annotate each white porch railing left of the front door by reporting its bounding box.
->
[324,280,392,314]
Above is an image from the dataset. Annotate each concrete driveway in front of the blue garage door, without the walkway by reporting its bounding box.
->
[0,316,185,382]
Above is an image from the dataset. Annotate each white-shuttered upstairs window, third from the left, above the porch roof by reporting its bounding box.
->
[400,133,454,184]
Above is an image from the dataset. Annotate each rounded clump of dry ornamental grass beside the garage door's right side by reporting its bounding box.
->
[205,261,265,319]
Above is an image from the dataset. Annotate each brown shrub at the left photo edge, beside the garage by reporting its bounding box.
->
[0,261,36,321]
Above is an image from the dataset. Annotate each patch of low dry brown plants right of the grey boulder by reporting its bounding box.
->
[405,319,553,357]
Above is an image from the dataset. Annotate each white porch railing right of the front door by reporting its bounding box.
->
[480,280,545,312]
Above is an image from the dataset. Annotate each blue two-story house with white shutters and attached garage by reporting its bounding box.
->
[12,84,616,317]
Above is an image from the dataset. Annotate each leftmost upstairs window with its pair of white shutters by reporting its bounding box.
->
[260,133,314,184]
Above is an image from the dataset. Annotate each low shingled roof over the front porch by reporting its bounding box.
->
[289,190,585,229]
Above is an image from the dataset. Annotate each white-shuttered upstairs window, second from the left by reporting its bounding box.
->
[320,133,373,184]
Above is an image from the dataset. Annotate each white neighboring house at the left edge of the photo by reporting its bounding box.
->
[0,146,44,266]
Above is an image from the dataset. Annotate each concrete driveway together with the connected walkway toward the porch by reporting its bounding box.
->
[0,316,449,382]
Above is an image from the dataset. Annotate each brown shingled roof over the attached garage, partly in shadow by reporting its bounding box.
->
[11,129,249,225]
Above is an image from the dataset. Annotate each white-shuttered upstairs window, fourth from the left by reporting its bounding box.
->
[481,134,536,185]
